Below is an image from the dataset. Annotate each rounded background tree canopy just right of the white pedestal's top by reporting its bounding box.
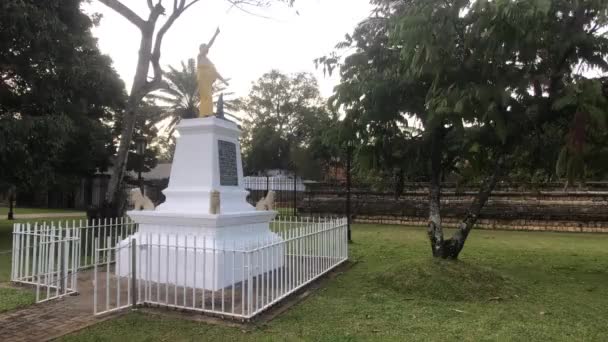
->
[240,70,337,178]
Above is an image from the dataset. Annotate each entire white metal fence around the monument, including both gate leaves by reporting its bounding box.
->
[11,218,348,319]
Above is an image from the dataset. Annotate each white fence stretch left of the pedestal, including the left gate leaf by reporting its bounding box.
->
[11,218,137,302]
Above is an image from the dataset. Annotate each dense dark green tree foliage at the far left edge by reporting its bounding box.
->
[0,0,125,195]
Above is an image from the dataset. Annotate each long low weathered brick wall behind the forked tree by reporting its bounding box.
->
[298,191,608,233]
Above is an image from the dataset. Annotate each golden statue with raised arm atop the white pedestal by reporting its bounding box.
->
[196,28,228,118]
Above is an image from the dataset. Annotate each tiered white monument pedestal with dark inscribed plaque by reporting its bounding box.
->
[117,117,283,291]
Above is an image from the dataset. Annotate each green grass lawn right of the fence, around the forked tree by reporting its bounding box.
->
[63,225,608,341]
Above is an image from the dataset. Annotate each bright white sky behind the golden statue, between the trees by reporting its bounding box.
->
[85,0,371,97]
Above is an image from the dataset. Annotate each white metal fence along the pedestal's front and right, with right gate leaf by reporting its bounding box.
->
[94,218,348,319]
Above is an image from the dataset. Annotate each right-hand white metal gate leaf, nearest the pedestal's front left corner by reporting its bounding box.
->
[93,236,139,315]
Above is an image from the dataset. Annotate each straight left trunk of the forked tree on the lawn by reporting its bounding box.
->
[427,127,444,257]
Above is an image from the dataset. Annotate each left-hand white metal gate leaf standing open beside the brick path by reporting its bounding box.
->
[11,224,80,303]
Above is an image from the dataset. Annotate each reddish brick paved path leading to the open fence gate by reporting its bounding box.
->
[0,271,120,342]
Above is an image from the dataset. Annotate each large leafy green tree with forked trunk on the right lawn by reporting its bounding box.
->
[317,0,608,258]
